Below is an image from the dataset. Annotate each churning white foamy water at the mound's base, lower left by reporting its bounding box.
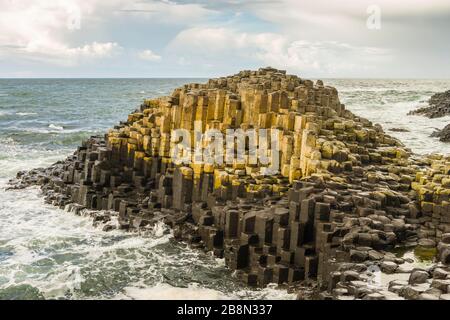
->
[0,179,290,299]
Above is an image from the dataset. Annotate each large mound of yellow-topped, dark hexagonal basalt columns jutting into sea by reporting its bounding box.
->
[11,68,450,300]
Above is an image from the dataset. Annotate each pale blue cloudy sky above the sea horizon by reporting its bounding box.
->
[0,0,450,79]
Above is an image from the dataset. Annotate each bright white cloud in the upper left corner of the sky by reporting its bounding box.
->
[0,0,121,65]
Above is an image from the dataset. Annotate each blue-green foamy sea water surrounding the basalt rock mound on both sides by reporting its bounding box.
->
[0,79,450,299]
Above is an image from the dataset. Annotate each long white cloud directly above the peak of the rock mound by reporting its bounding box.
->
[169,28,391,76]
